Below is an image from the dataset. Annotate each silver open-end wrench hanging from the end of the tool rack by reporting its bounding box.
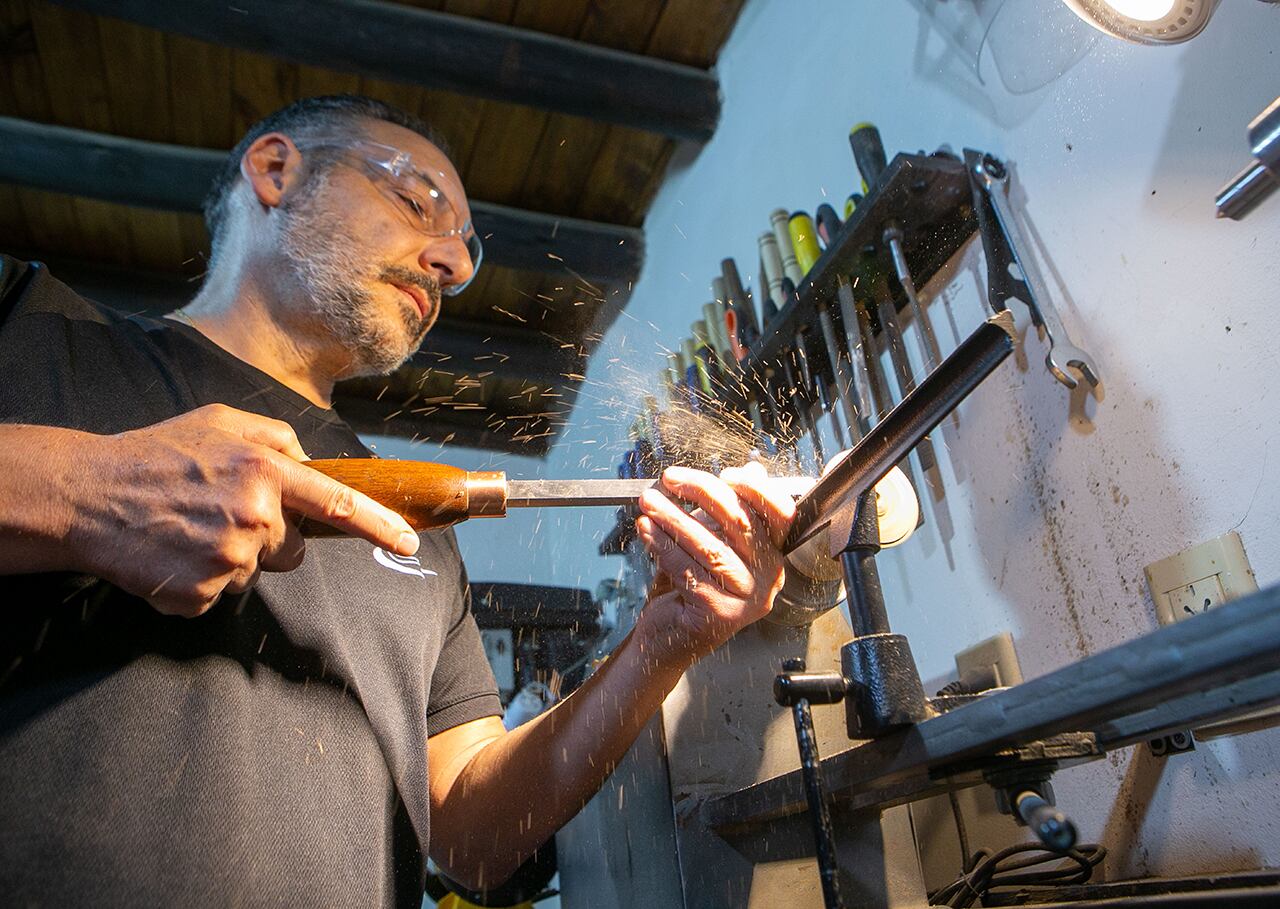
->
[965,150,1098,388]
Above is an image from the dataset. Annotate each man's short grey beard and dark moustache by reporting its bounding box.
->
[280,172,440,379]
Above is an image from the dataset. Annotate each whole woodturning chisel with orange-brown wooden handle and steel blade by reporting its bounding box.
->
[303,457,813,536]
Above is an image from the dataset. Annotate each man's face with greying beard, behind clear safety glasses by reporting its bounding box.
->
[279,120,472,378]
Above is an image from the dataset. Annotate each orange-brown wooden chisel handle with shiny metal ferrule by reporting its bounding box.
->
[302,458,507,536]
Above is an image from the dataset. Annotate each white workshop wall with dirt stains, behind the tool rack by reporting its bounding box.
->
[384,0,1280,874]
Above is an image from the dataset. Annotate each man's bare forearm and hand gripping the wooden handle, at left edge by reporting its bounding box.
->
[0,405,417,616]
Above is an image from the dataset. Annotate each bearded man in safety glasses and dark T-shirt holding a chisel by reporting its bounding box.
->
[0,96,792,905]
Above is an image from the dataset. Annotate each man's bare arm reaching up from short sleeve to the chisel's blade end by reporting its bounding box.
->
[430,470,794,887]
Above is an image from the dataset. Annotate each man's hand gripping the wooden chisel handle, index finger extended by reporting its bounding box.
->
[68,405,417,617]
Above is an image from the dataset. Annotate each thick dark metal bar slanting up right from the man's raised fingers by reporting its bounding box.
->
[782,312,1014,552]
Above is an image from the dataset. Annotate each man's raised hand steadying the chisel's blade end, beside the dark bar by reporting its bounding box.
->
[636,463,795,662]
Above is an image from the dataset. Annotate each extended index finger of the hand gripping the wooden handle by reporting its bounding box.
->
[280,462,419,556]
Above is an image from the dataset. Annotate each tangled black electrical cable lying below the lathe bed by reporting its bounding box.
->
[929,842,1107,909]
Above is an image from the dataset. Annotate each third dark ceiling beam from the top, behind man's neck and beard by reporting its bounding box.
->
[17,251,584,388]
